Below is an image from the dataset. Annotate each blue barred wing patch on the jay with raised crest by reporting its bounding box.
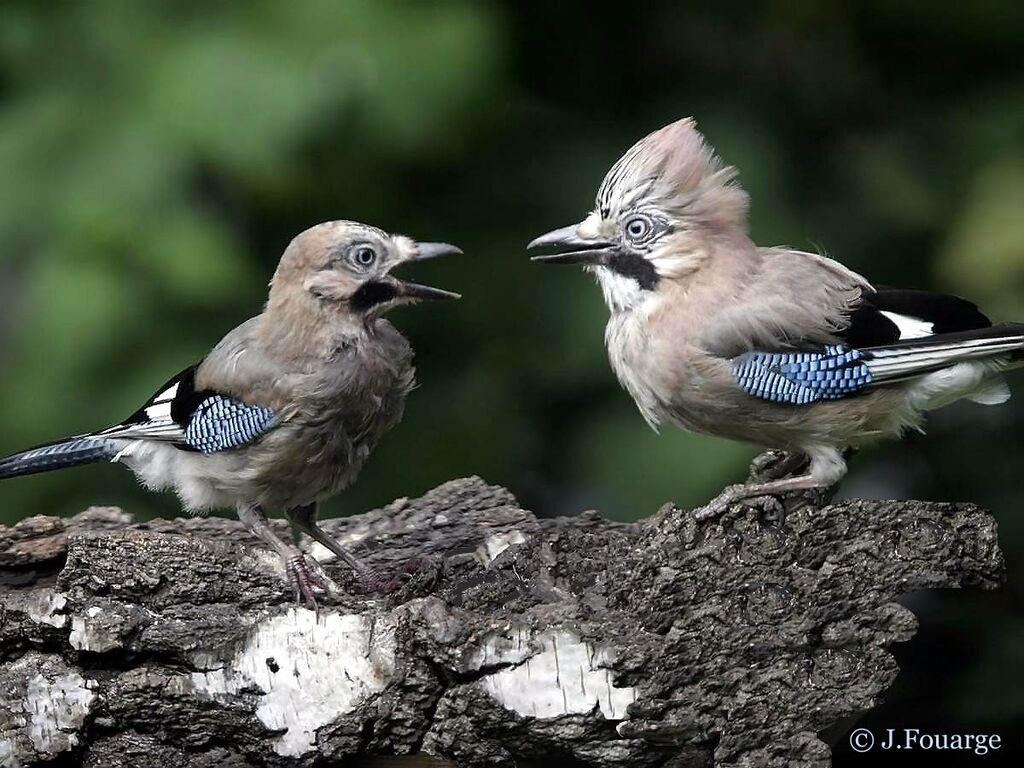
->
[732,344,871,406]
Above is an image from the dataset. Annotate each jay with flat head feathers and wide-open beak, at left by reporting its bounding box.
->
[0,221,461,605]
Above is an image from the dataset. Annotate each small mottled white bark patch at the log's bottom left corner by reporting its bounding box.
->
[25,672,96,755]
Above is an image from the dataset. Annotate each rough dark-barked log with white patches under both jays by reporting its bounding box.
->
[0,460,1004,768]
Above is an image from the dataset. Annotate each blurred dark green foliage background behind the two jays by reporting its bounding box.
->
[0,0,1024,752]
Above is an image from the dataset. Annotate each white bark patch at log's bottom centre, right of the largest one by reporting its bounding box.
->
[477,630,636,720]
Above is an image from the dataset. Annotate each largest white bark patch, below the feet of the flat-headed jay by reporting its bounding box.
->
[188,608,395,757]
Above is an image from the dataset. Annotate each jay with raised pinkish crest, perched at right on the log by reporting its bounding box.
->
[529,119,1024,517]
